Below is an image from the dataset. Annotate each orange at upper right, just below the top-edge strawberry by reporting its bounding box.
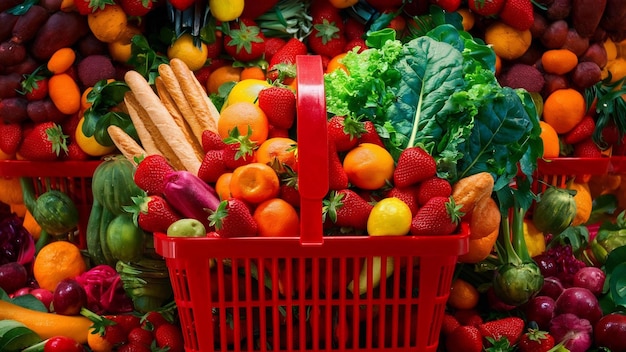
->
[485,22,532,60]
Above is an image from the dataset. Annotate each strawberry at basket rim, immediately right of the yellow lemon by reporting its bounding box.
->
[411,197,460,236]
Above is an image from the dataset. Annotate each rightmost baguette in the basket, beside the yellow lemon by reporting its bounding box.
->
[170,58,219,134]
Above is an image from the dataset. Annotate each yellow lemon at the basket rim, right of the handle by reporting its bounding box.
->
[367,197,413,236]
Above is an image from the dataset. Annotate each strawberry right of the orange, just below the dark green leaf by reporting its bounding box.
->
[393,147,437,187]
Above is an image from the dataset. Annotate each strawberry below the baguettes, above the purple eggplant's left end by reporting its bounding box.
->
[133,154,174,195]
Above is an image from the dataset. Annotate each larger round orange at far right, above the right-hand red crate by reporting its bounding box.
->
[543,88,587,134]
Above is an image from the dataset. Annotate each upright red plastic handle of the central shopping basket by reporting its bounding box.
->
[296,55,328,245]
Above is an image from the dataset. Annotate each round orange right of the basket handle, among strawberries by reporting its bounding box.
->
[343,143,395,190]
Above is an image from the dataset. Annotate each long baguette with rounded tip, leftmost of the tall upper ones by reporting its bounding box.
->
[124,70,202,175]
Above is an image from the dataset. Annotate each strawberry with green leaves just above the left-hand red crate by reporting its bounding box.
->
[17,122,68,161]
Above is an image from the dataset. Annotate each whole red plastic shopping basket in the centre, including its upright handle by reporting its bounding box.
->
[155,56,469,352]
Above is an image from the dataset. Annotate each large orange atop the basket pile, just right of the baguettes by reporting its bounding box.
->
[217,101,269,145]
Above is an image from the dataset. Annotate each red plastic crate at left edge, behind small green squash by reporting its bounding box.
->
[0,160,101,248]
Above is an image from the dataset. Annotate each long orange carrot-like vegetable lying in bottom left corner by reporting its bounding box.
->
[0,300,92,344]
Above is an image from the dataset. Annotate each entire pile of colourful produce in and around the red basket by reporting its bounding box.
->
[0,0,626,352]
